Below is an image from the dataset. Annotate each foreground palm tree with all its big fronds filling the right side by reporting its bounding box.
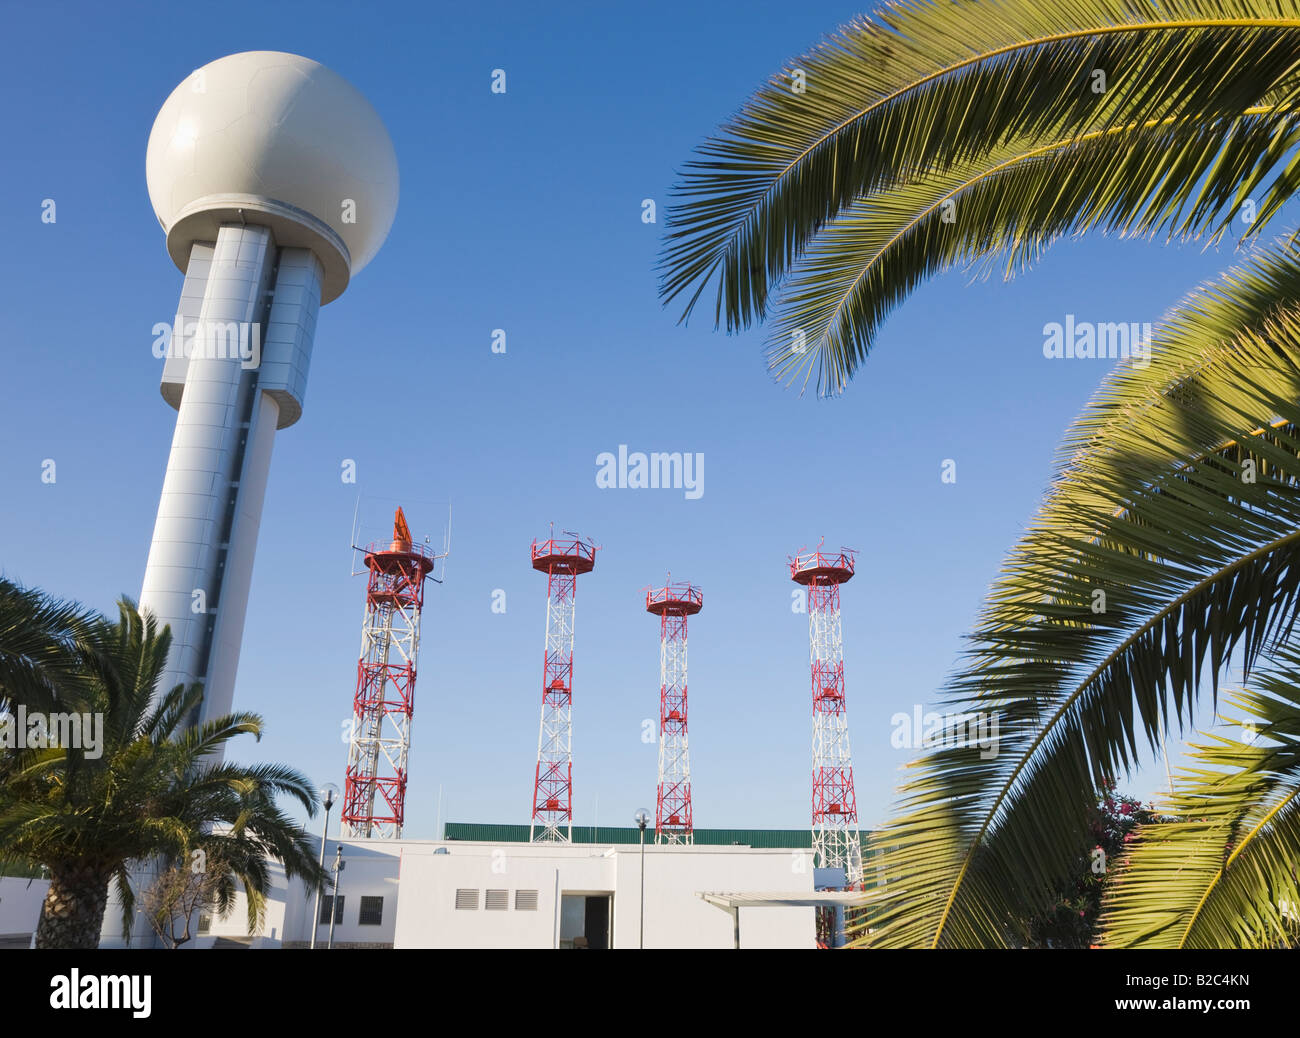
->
[662,0,1300,947]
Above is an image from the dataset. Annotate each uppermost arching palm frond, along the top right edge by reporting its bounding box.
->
[660,0,1300,392]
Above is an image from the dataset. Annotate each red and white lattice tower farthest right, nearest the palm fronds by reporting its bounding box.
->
[790,549,862,887]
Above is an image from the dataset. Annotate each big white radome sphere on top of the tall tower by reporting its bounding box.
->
[144,51,398,302]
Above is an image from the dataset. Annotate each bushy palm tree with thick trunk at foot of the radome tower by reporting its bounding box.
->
[0,598,325,948]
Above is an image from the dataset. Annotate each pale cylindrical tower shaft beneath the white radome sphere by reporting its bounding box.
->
[140,224,321,721]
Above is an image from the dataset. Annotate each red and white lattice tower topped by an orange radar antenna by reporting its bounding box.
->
[342,509,438,838]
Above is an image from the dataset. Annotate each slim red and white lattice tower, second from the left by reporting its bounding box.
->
[528,535,599,843]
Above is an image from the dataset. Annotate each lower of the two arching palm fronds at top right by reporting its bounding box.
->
[768,109,1300,393]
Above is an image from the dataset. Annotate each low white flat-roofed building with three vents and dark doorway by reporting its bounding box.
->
[183,834,828,950]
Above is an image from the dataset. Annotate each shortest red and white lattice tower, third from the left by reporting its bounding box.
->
[646,584,705,843]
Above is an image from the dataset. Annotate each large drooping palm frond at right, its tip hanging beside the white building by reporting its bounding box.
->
[872,239,1300,946]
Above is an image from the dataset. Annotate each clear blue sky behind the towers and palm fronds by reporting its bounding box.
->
[0,0,1258,838]
